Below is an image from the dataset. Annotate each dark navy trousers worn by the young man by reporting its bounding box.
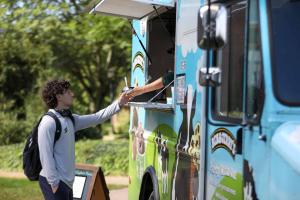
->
[39,176,73,200]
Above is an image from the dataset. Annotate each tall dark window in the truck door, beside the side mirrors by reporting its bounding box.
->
[213,2,246,122]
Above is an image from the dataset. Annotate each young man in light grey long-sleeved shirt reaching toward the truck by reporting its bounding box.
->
[38,80,130,200]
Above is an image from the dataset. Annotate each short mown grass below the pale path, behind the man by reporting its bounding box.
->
[0,178,127,200]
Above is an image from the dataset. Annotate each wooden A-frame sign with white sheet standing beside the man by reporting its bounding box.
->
[73,164,109,200]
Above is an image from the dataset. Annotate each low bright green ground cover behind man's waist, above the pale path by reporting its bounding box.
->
[0,140,128,175]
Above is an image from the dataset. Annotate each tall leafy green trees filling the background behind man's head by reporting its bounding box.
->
[0,0,131,144]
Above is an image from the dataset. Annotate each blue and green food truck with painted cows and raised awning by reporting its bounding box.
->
[90,0,300,200]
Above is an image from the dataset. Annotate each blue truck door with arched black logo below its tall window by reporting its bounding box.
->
[205,1,247,200]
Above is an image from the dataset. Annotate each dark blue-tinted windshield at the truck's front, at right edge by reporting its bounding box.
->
[270,0,300,106]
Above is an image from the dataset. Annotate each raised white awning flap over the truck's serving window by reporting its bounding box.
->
[89,0,175,19]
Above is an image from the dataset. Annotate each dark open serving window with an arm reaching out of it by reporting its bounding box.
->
[147,8,176,103]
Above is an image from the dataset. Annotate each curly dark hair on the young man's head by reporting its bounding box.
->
[42,80,71,108]
